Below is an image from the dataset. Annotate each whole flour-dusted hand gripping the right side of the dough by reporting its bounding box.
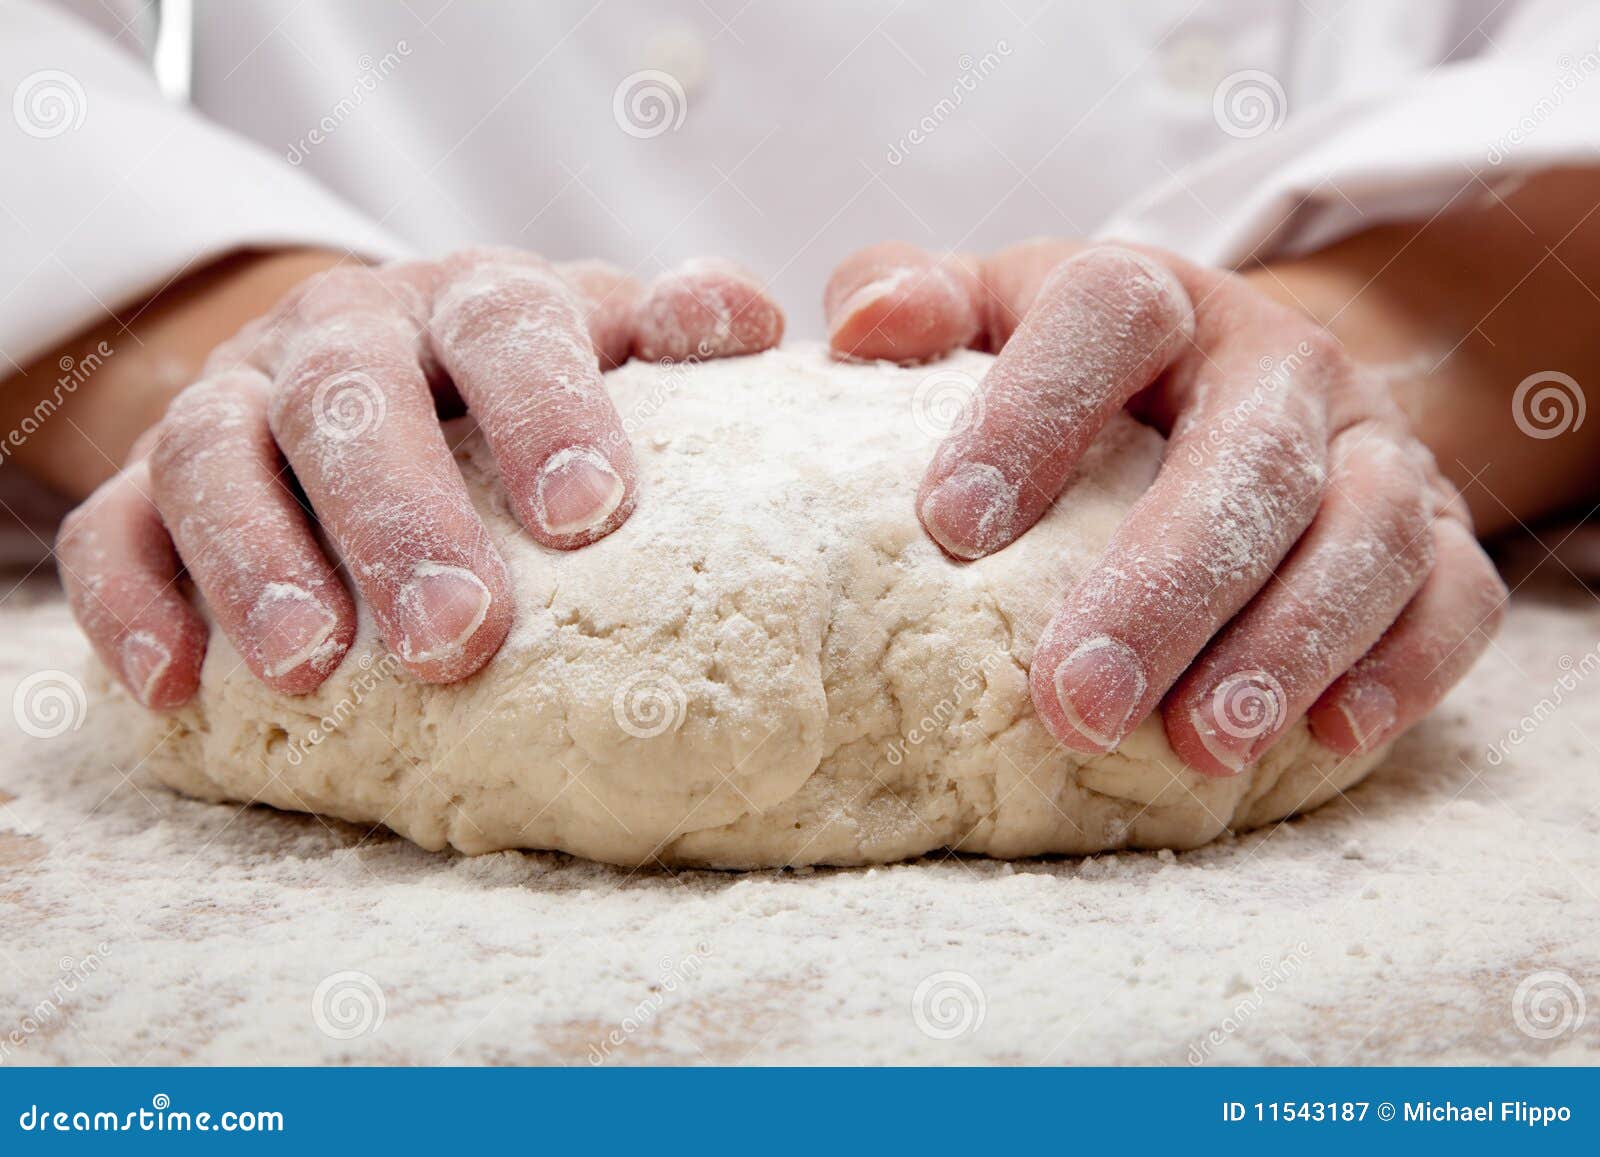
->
[826,242,1504,776]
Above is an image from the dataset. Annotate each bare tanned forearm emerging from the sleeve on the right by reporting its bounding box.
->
[1245,170,1600,533]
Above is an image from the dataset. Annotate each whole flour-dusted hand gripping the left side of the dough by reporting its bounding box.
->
[56,250,782,709]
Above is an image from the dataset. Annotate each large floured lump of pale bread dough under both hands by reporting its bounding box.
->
[118,346,1378,867]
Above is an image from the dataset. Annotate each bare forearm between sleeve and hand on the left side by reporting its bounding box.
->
[0,250,352,498]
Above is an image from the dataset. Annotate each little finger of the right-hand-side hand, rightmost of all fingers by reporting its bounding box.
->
[1310,518,1506,755]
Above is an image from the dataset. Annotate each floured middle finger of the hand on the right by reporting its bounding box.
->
[1030,334,1328,752]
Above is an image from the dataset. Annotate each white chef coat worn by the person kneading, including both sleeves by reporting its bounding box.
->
[0,0,1600,376]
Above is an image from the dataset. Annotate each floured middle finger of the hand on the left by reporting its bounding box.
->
[267,274,505,683]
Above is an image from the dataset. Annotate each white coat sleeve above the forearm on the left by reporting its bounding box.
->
[0,0,405,378]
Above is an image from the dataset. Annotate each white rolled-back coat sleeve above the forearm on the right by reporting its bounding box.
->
[1098,0,1600,267]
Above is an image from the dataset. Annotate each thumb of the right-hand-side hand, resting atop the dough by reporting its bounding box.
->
[822,242,984,362]
